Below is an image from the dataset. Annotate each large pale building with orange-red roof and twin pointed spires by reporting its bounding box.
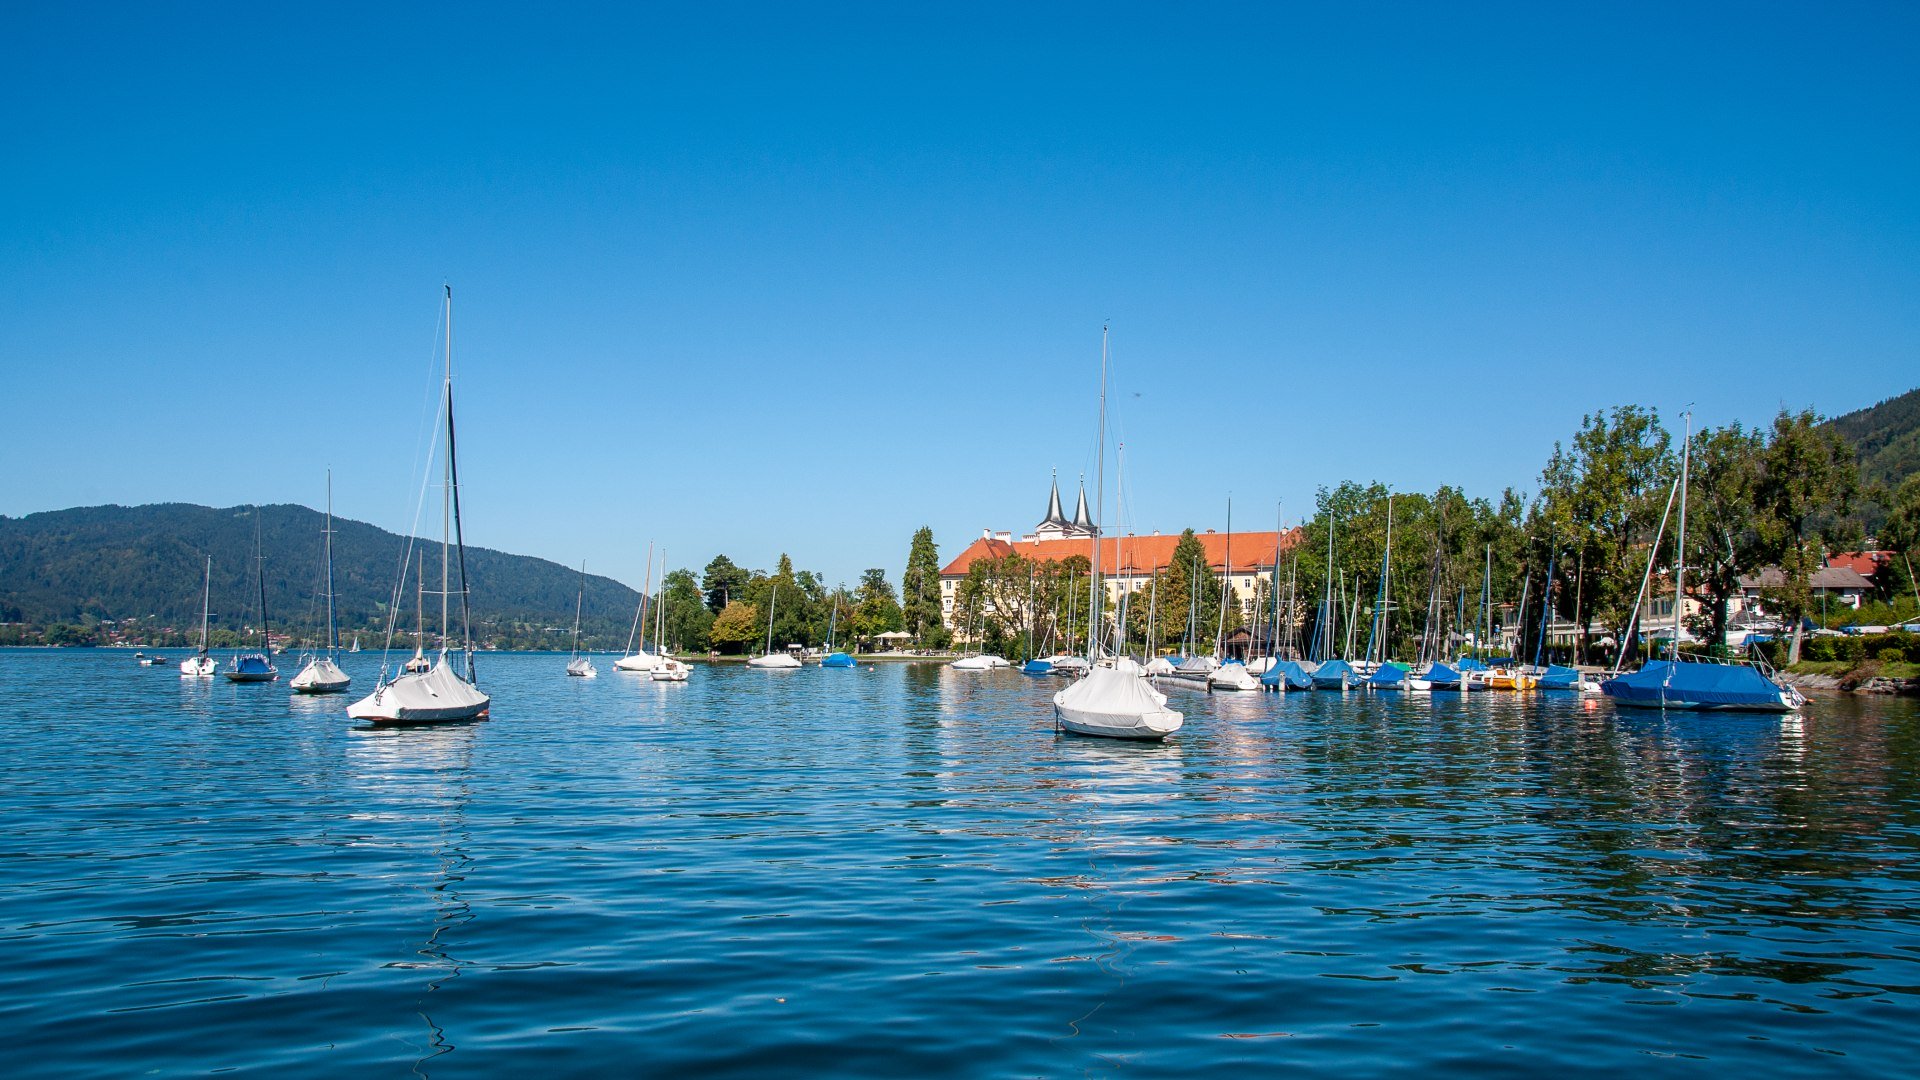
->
[941,479,1300,628]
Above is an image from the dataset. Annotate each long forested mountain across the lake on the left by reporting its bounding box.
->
[0,503,639,648]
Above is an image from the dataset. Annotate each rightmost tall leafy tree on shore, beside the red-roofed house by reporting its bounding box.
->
[1755,409,1860,663]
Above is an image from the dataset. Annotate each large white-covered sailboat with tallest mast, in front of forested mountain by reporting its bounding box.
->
[348,286,493,724]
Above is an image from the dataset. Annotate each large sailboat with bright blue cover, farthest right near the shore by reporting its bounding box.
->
[1599,413,1807,713]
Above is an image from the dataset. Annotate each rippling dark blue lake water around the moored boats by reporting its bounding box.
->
[0,650,1920,1076]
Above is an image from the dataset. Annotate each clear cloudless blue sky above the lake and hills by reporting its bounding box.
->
[0,4,1920,584]
